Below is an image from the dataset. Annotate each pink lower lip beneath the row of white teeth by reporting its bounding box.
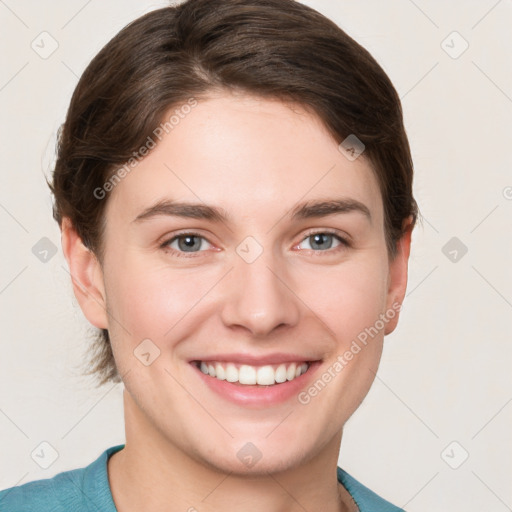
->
[191,361,321,407]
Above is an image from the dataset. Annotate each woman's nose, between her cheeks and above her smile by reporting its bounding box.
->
[221,251,301,337]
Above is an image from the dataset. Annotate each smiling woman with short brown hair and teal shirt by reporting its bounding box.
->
[0,0,417,512]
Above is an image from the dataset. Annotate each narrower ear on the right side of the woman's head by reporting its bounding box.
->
[384,217,413,334]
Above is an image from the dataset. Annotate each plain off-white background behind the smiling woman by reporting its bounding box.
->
[0,0,512,512]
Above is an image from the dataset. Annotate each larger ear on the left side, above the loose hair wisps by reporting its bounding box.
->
[61,217,108,329]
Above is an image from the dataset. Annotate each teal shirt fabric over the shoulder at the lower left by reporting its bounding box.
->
[0,445,122,512]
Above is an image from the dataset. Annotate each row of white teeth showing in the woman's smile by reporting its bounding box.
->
[194,361,311,386]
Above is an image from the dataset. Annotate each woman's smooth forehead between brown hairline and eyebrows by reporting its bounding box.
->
[107,93,382,225]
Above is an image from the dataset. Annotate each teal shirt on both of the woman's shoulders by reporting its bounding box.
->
[0,444,404,512]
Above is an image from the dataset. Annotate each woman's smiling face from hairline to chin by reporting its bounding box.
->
[72,93,406,472]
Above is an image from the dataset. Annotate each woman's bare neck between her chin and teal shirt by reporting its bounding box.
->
[108,390,357,512]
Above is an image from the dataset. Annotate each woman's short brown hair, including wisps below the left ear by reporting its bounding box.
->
[49,0,418,385]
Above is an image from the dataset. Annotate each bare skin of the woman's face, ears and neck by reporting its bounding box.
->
[62,92,410,512]
